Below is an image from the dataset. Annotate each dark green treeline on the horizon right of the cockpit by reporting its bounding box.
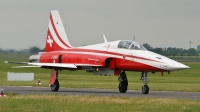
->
[143,43,200,57]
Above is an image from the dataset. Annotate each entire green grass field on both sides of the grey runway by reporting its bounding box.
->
[0,56,200,112]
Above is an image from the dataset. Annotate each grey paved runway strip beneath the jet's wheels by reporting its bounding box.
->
[0,86,200,100]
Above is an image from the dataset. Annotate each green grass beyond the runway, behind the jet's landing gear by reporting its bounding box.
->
[0,57,200,92]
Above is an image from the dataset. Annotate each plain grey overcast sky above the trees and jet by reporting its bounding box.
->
[0,0,200,49]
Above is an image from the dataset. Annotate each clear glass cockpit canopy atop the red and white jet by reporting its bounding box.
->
[118,40,147,51]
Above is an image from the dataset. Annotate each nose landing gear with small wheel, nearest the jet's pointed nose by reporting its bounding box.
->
[140,72,149,94]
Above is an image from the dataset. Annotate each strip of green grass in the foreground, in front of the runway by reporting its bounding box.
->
[0,94,200,112]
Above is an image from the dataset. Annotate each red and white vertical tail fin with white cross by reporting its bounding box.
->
[45,10,72,52]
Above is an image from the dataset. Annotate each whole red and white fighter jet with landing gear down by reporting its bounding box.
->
[6,10,189,94]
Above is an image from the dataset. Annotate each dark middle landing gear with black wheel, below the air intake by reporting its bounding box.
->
[118,71,128,93]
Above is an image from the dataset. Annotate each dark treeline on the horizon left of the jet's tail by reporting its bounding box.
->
[0,46,44,55]
